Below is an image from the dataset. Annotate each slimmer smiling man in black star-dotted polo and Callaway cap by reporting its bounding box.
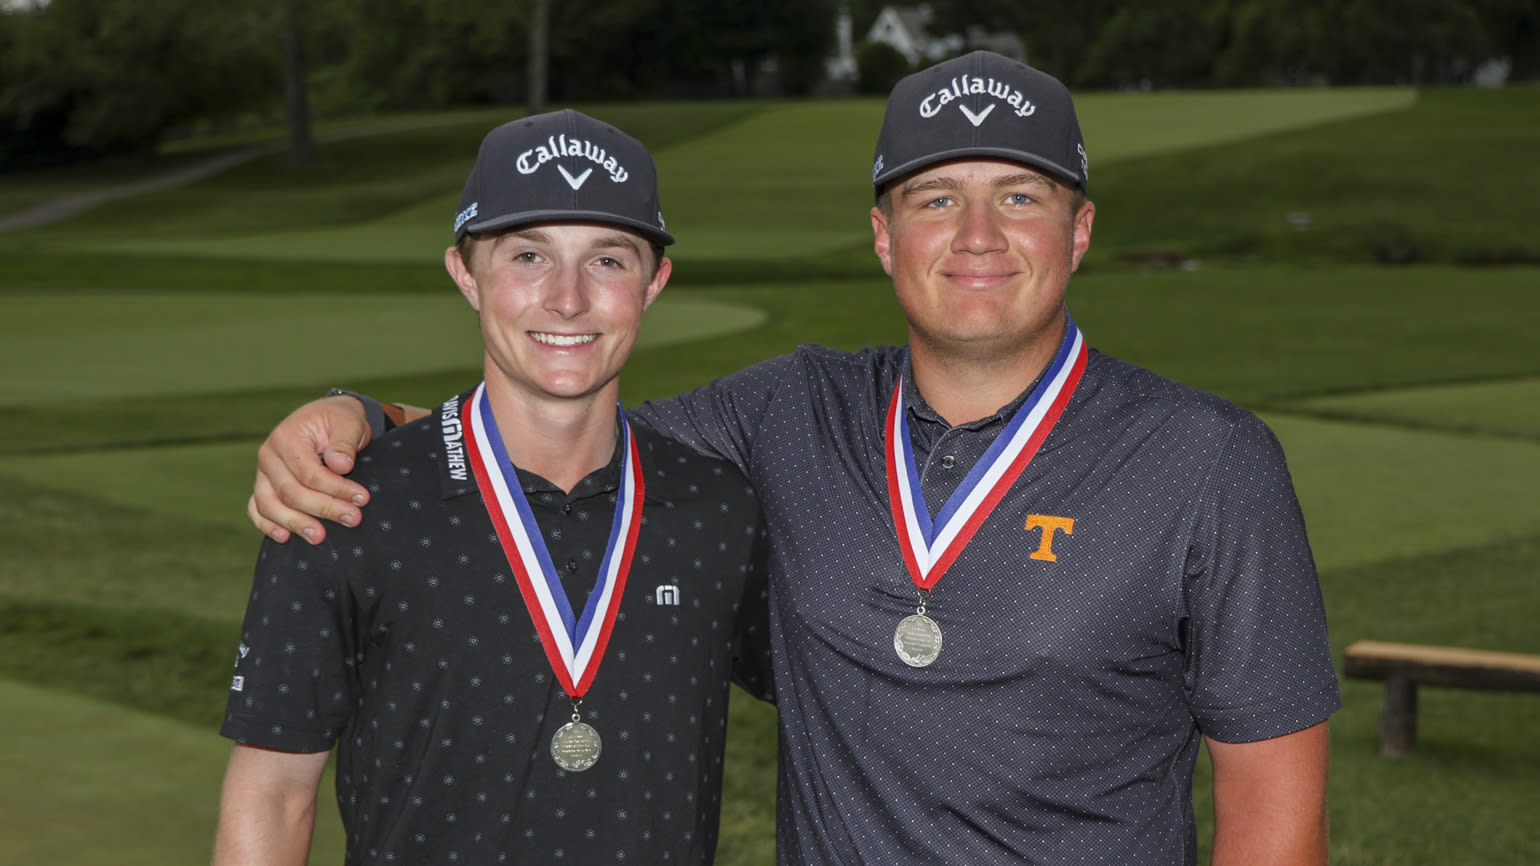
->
[216,111,768,864]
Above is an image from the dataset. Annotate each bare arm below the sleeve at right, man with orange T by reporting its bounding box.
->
[1206,721,1327,866]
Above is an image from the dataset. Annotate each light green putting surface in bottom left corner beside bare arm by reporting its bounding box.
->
[0,681,342,866]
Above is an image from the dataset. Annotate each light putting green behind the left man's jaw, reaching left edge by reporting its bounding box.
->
[0,289,765,405]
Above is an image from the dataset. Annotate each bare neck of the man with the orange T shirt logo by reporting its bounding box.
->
[909,317,1064,427]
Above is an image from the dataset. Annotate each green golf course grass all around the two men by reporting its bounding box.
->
[0,88,1540,866]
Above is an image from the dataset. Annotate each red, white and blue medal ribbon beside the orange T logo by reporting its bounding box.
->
[886,313,1089,592]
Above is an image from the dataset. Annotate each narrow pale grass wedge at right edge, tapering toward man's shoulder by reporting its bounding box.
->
[1291,379,1540,436]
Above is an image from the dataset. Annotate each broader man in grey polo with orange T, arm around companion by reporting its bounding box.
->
[253,52,1340,866]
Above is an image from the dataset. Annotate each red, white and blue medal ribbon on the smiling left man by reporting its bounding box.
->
[465,384,644,701]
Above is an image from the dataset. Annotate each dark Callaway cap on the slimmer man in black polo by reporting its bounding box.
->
[454,108,675,247]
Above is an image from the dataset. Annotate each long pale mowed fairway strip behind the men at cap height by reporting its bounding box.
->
[51,88,1417,260]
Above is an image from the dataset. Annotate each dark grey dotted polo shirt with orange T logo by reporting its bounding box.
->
[631,347,1340,866]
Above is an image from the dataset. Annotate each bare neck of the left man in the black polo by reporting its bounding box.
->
[487,378,619,492]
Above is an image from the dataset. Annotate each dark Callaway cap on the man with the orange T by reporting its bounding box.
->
[872,51,1087,194]
